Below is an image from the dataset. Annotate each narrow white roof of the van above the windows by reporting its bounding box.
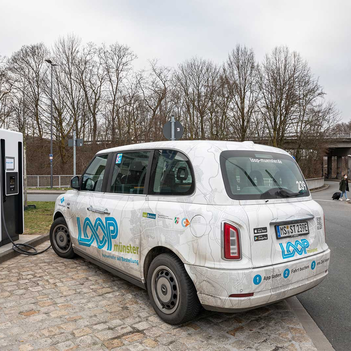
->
[98,140,289,155]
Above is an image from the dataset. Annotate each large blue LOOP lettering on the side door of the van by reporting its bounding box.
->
[77,217,118,251]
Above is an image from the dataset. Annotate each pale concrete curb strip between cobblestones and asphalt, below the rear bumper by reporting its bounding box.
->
[286,296,335,351]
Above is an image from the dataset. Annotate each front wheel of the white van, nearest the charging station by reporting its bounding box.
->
[50,217,75,258]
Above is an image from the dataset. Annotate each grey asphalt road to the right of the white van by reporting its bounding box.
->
[298,182,351,351]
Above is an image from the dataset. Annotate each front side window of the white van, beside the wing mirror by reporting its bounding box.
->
[82,155,108,191]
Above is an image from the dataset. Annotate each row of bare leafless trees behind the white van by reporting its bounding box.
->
[0,36,340,179]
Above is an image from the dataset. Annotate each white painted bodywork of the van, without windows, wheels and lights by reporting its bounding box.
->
[55,141,330,310]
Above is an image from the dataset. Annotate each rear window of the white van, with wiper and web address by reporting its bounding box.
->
[220,151,309,200]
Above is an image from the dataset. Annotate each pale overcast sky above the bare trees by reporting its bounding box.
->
[0,0,351,121]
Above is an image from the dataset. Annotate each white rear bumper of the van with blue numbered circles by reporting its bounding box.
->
[185,250,330,312]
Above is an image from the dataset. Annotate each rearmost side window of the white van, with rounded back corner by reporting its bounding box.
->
[150,150,195,195]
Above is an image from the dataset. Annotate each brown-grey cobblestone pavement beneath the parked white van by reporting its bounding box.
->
[0,243,316,351]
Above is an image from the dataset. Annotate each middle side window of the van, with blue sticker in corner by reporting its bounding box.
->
[111,151,150,194]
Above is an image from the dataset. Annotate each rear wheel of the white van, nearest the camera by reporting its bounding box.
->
[147,253,201,325]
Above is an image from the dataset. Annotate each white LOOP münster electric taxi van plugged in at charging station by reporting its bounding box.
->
[50,141,330,324]
